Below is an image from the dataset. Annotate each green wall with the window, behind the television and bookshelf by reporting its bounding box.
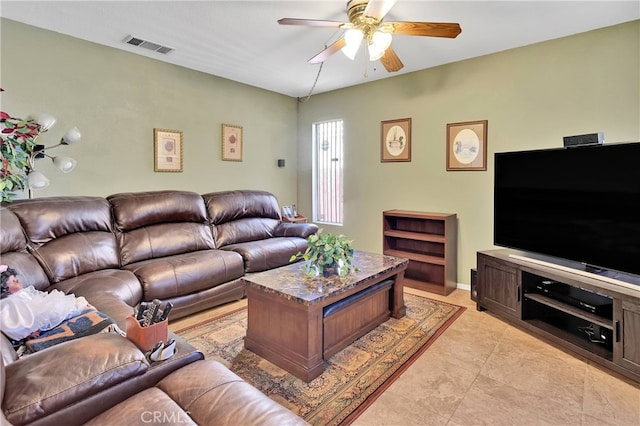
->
[298,21,640,284]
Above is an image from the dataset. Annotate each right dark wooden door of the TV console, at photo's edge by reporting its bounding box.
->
[613,299,640,374]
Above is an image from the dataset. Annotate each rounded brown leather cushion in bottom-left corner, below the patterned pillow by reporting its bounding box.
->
[2,333,149,424]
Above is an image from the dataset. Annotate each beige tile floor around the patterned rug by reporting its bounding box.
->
[170,289,640,426]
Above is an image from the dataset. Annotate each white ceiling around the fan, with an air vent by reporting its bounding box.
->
[0,0,640,97]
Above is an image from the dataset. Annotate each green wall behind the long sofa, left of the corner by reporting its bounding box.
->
[0,19,297,204]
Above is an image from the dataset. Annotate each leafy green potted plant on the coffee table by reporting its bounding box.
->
[289,229,357,276]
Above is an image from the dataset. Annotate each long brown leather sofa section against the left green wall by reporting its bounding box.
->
[2,190,318,319]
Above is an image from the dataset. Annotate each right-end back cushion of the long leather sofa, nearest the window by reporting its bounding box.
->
[202,190,281,247]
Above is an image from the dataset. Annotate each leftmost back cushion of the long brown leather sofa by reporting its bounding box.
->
[8,197,119,283]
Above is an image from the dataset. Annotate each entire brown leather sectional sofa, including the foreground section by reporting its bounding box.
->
[0,191,318,425]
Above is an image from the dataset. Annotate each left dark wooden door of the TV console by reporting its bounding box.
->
[477,253,522,319]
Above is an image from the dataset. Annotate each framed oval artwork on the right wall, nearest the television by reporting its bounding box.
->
[447,120,487,171]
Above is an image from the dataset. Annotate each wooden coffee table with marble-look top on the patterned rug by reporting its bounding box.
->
[244,251,409,382]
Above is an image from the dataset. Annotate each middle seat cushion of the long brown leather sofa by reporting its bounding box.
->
[125,250,244,301]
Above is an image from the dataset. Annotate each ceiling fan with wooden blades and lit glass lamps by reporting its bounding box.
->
[278,0,462,72]
